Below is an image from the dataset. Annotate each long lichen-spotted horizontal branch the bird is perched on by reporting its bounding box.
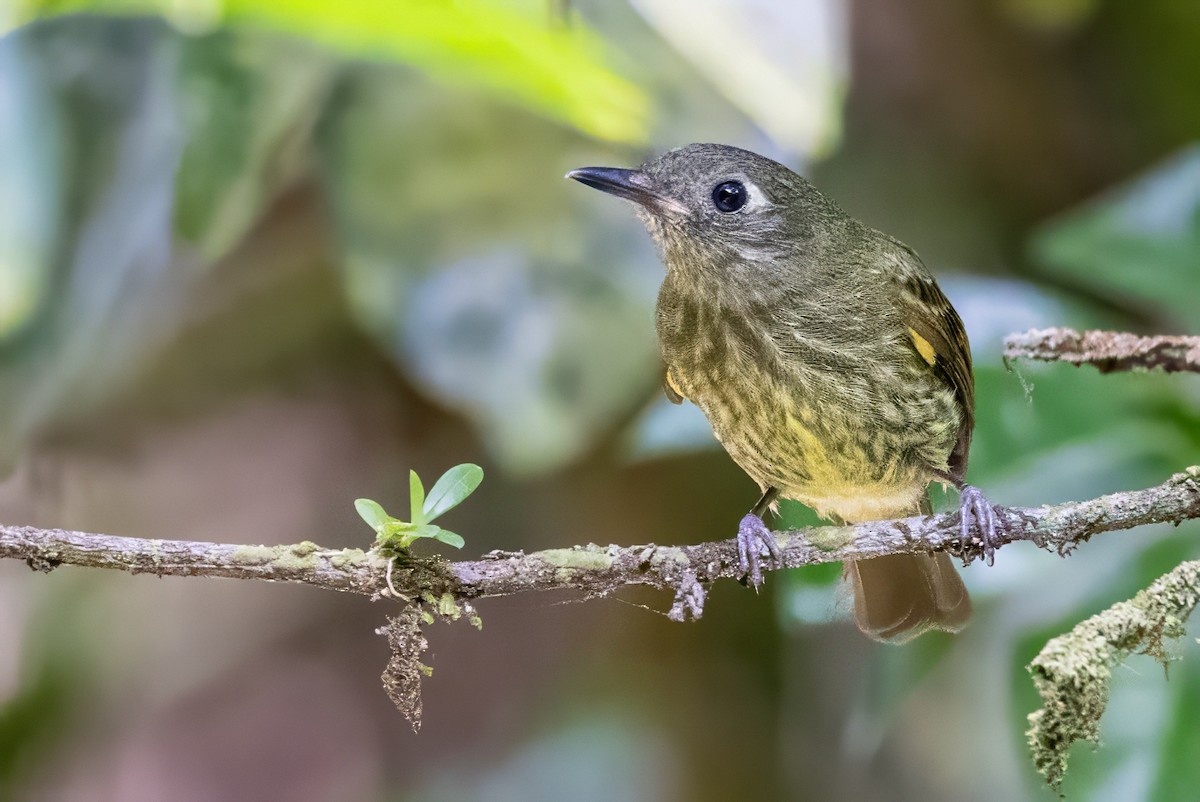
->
[0,467,1200,620]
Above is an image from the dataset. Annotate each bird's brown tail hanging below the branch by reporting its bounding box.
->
[846,498,971,644]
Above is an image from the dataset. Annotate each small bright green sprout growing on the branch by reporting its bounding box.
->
[354,462,484,549]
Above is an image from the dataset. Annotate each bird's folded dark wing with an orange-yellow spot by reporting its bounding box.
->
[888,238,974,481]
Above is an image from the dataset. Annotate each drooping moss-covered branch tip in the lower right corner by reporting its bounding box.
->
[1026,561,1200,789]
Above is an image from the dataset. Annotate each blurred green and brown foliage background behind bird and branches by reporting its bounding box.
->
[0,0,1200,800]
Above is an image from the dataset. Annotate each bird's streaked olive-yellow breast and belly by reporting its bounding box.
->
[658,285,949,520]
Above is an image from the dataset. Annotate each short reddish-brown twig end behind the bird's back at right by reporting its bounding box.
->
[1004,329,1200,373]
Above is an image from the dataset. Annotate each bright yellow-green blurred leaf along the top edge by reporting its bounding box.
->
[14,0,647,143]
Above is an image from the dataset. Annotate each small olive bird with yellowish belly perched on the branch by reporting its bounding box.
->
[566,143,1006,642]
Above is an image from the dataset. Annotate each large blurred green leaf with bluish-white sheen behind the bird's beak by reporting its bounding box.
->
[319,67,662,474]
